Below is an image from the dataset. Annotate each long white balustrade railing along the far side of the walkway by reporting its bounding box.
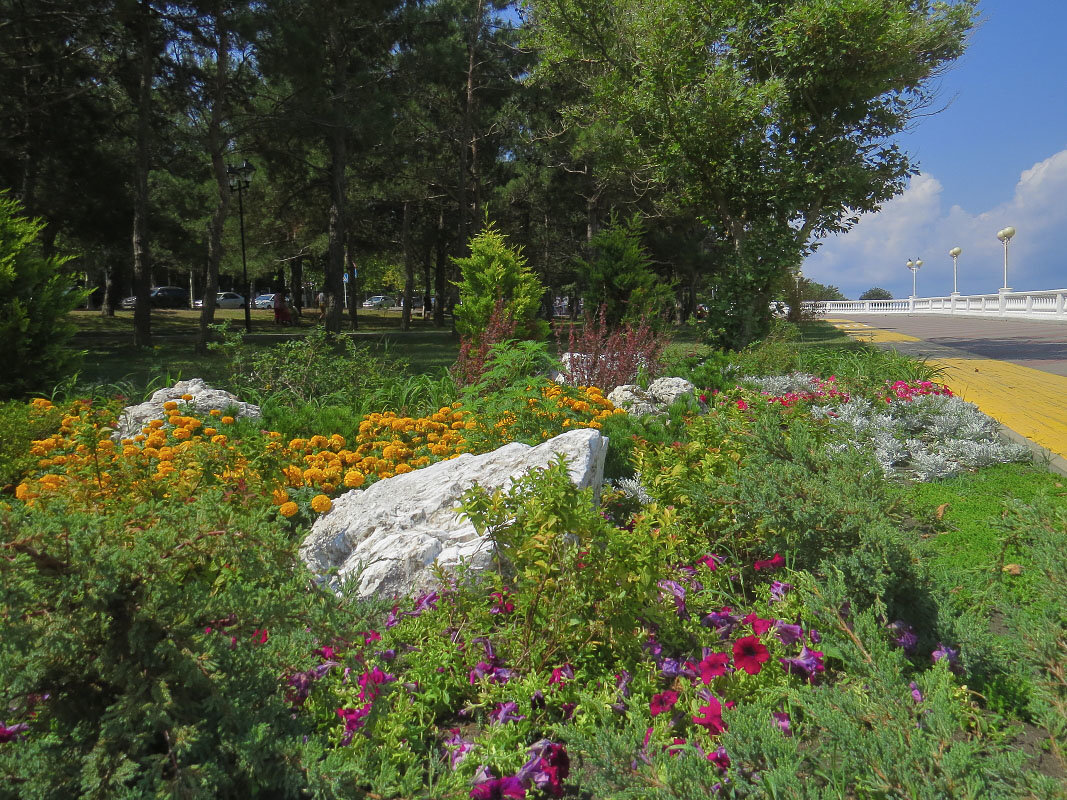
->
[803,289,1067,322]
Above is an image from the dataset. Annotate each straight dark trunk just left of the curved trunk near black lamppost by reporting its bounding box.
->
[133,0,155,348]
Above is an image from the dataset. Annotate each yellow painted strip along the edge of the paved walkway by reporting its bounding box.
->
[827,320,1067,458]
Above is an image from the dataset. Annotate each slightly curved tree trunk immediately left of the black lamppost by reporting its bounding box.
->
[196,3,230,353]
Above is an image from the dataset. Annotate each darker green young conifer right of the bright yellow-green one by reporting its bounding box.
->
[576,214,674,329]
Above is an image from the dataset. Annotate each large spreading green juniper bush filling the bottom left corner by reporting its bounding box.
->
[0,491,339,798]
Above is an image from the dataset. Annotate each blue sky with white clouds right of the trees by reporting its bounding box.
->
[803,0,1067,299]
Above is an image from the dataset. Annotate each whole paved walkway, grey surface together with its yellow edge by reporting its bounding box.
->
[827,315,1067,474]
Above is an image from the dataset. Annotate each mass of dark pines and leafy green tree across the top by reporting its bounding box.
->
[0,0,975,347]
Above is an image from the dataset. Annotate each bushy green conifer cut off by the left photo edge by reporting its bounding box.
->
[0,193,85,399]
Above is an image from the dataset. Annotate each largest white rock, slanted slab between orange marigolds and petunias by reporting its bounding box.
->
[300,428,607,597]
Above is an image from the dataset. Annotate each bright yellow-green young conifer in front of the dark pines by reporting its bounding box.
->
[452,223,548,340]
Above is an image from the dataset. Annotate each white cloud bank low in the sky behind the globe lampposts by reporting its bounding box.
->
[803,149,1067,298]
